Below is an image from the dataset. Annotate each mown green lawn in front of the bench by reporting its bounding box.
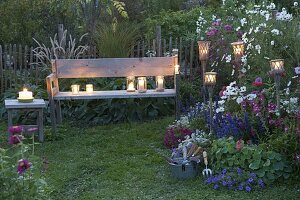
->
[1,118,300,200]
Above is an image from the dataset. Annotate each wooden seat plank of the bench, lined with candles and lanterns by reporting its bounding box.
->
[54,89,176,100]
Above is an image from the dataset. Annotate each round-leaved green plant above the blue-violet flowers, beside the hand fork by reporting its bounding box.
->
[210,138,292,183]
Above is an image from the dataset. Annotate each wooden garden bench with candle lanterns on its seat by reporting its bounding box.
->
[46,55,179,130]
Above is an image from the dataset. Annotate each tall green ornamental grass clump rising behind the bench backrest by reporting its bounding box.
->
[94,22,139,58]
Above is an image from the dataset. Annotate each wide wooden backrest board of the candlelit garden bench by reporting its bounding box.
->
[55,57,177,78]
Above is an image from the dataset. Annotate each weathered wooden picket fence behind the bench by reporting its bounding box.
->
[0,37,199,94]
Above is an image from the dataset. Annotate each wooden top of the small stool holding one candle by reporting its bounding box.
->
[5,99,46,109]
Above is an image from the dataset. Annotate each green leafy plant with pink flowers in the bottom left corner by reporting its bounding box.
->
[0,138,50,199]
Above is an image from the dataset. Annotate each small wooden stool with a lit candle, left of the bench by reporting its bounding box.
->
[5,99,46,142]
